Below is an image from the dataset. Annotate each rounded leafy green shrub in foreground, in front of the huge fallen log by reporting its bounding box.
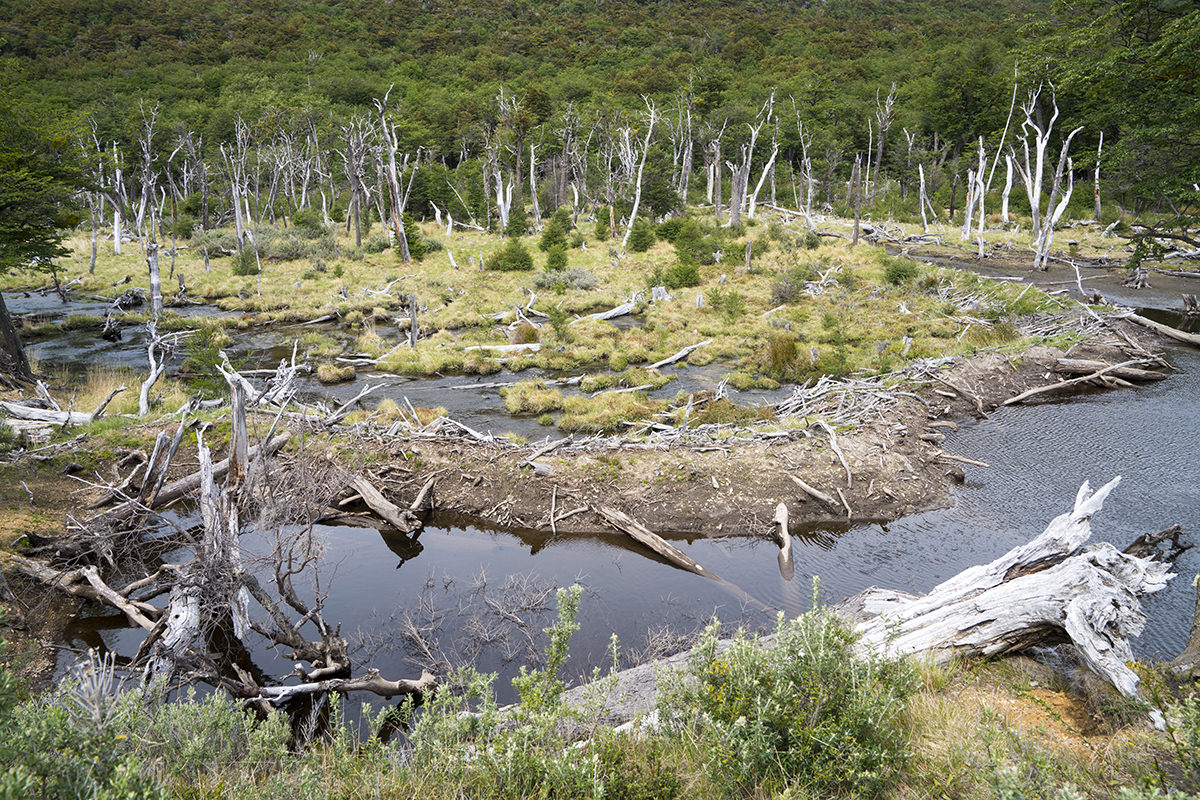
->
[660,609,916,796]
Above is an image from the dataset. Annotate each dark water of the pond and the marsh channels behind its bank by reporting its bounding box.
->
[6,275,1200,702]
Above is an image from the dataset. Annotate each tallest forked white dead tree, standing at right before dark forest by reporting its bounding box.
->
[1013,86,1082,270]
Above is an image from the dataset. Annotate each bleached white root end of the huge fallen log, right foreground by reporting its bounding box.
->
[838,477,1174,698]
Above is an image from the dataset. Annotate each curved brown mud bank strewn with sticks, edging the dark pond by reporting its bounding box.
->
[348,331,1161,537]
